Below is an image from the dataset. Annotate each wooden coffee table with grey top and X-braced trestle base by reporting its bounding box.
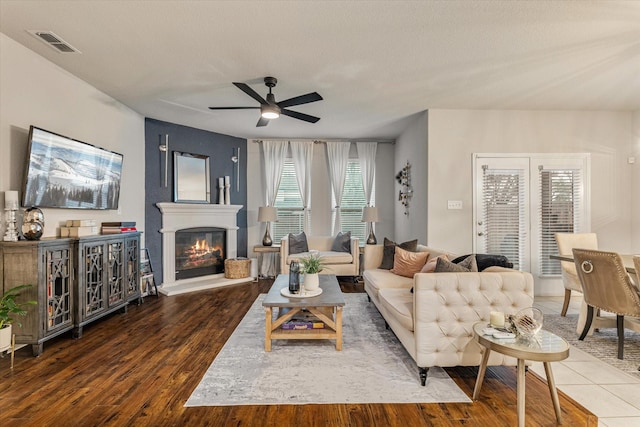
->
[262,274,345,351]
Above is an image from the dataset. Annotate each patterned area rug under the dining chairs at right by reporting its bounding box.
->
[544,314,640,378]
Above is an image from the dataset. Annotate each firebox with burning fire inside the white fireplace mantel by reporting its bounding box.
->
[175,227,227,280]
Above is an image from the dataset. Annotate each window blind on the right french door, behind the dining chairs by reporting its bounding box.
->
[538,166,584,276]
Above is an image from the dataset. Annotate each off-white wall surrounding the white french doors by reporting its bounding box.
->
[428,110,640,295]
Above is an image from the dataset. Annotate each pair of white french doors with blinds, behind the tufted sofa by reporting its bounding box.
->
[473,153,591,277]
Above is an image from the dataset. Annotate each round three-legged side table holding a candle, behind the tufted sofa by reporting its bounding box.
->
[473,322,569,427]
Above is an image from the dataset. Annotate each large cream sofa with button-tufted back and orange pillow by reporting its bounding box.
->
[363,245,533,385]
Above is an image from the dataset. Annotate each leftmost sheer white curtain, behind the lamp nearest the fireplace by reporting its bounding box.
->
[261,141,288,276]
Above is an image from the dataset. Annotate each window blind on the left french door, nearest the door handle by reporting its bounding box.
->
[482,166,527,269]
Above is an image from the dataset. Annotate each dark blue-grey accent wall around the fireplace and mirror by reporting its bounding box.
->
[141,118,247,284]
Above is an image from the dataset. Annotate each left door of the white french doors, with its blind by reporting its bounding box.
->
[474,157,531,271]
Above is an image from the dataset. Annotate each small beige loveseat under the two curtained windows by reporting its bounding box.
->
[280,236,360,277]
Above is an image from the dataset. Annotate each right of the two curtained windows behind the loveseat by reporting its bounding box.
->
[331,159,375,242]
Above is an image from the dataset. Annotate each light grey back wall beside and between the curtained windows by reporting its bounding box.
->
[247,141,394,256]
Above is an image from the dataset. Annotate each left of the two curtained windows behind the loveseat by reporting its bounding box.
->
[272,159,311,242]
